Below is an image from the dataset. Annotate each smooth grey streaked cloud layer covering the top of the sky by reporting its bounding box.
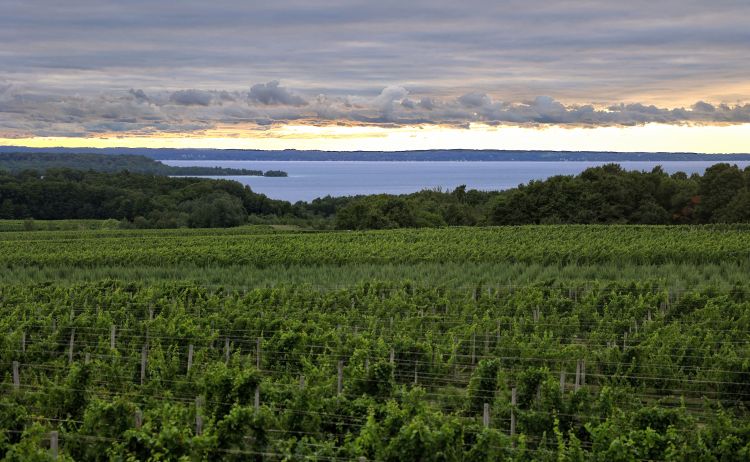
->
[0,0,750,113]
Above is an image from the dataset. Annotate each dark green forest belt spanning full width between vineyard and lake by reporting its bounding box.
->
[0,162,750,230]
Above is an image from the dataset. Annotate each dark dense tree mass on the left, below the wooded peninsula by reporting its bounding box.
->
[0,170,291,228]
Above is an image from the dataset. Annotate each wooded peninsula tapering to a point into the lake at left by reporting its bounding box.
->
[0,150,287,176]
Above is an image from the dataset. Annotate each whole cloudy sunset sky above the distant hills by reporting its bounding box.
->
[0,0,750,152]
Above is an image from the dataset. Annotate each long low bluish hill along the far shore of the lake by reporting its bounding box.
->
[0,146,750,162]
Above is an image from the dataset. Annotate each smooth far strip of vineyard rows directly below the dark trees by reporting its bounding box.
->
[0,225,750,268]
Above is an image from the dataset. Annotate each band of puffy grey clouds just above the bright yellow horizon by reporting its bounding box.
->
[0,81,750,137]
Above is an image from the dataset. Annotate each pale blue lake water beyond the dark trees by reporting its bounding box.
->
[162,160,750,202]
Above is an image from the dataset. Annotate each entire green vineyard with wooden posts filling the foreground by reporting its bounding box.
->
[0,226,750,461]
